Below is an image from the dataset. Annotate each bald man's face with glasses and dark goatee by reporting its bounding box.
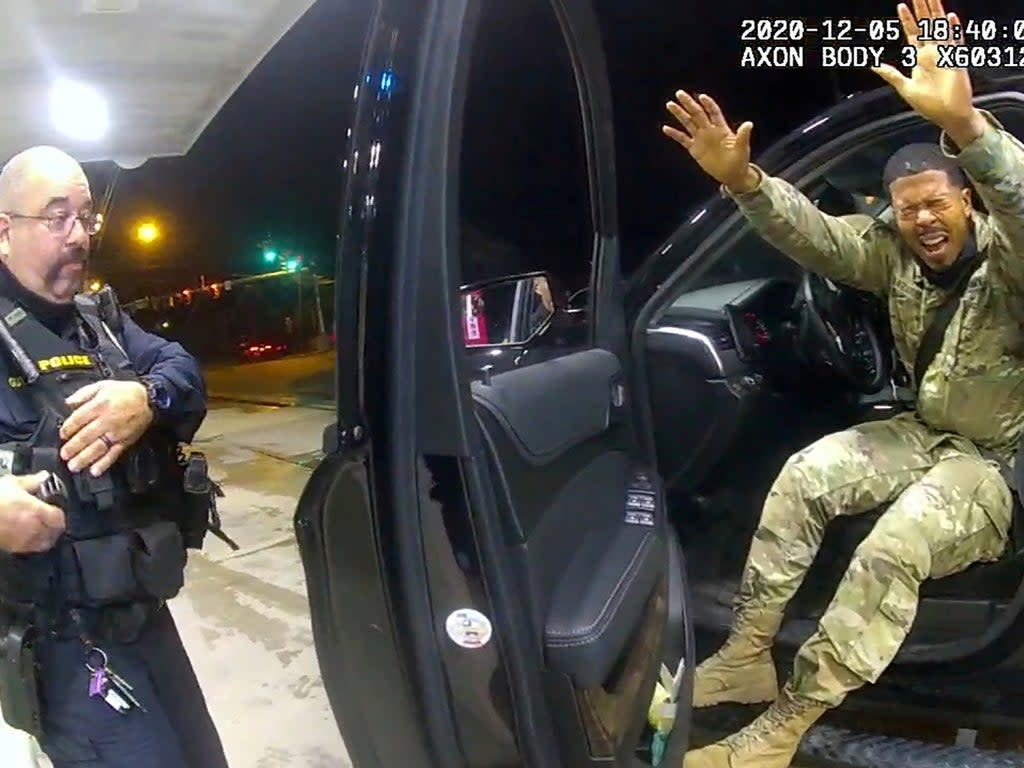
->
[0,164,92,303]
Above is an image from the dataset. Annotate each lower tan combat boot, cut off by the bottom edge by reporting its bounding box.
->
[683,688,828,768]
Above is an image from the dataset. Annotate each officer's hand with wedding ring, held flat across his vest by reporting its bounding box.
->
[60,380,153,477]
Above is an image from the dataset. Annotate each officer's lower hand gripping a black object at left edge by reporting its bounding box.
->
[0,472,65,554]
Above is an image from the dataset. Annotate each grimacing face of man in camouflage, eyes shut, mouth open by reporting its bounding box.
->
[889,171,973,270]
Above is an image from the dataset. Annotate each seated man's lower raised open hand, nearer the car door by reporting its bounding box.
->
[662,91,757,191]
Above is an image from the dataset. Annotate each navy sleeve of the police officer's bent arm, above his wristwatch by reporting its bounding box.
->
[122,315,206,442]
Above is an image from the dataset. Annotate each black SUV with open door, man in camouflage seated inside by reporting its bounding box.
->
[296,0,1024,768]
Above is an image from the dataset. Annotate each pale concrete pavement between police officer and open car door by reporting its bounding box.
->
[0,406,350,768]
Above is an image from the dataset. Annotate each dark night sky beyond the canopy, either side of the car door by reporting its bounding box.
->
[90,0,1014,298]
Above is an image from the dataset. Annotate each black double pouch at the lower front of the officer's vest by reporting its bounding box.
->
[72,522,185,606]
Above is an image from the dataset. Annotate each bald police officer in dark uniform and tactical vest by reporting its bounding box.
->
[0,146,226,768]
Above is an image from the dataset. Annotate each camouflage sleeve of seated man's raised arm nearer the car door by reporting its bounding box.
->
[722,166,899,296]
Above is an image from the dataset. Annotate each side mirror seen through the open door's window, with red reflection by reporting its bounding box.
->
[459,272,555,347]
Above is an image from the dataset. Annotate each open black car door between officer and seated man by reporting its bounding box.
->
[296,0,692,768]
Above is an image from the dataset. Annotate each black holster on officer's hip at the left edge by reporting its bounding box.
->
[0,606,43,739]
